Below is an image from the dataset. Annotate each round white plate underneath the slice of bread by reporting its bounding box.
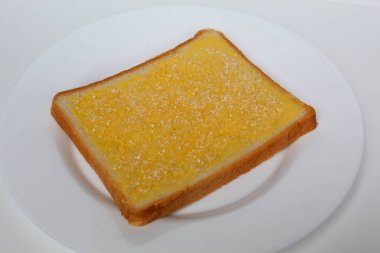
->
[0,7,363,253]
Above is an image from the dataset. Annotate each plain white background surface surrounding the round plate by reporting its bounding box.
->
[0,0,380,253]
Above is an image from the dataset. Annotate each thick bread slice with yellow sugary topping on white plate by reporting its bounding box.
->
[51,29,317,226]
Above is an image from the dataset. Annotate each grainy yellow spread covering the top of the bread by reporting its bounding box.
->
[67,31,304,205]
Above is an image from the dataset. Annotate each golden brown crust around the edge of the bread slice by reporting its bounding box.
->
[51,29,317,226]
